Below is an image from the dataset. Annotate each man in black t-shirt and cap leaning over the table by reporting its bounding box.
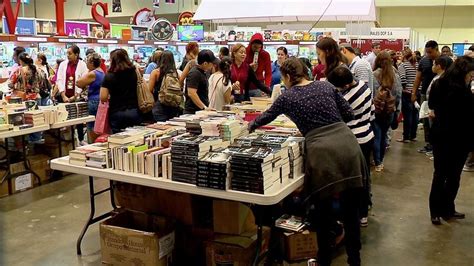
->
[184,49,219,114]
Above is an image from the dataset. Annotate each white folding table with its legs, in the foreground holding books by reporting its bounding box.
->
[51,156,304,263]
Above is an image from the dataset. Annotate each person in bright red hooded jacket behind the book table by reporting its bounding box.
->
[245,33,272,97]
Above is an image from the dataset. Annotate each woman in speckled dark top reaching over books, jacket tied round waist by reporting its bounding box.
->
[249,58,367,265]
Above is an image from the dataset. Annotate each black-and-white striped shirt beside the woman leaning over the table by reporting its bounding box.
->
[341,82,375,144]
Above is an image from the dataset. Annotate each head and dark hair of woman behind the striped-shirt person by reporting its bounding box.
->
[316,37,344,77]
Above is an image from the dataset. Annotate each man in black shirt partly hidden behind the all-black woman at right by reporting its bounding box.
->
[411,41,441,153]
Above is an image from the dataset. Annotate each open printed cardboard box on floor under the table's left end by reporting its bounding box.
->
[100,211,175,266]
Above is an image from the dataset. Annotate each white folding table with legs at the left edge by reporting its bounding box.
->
[0,125,49,194]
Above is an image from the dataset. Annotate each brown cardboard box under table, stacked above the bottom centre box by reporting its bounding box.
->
[213,200,256,235]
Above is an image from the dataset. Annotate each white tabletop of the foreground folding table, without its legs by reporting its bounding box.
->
[51,156,304,205]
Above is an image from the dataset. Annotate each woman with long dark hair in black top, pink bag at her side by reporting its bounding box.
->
[100,49,142,133]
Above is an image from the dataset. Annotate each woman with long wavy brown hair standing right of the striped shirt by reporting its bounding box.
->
[373,52,402,172]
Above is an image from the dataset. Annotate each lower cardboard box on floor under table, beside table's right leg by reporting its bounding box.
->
[206,227,270,266]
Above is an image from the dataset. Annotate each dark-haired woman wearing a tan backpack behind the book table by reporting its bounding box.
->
[148,51,182,122]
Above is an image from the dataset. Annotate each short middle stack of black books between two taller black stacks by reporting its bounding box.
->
[196,151,230,190]
